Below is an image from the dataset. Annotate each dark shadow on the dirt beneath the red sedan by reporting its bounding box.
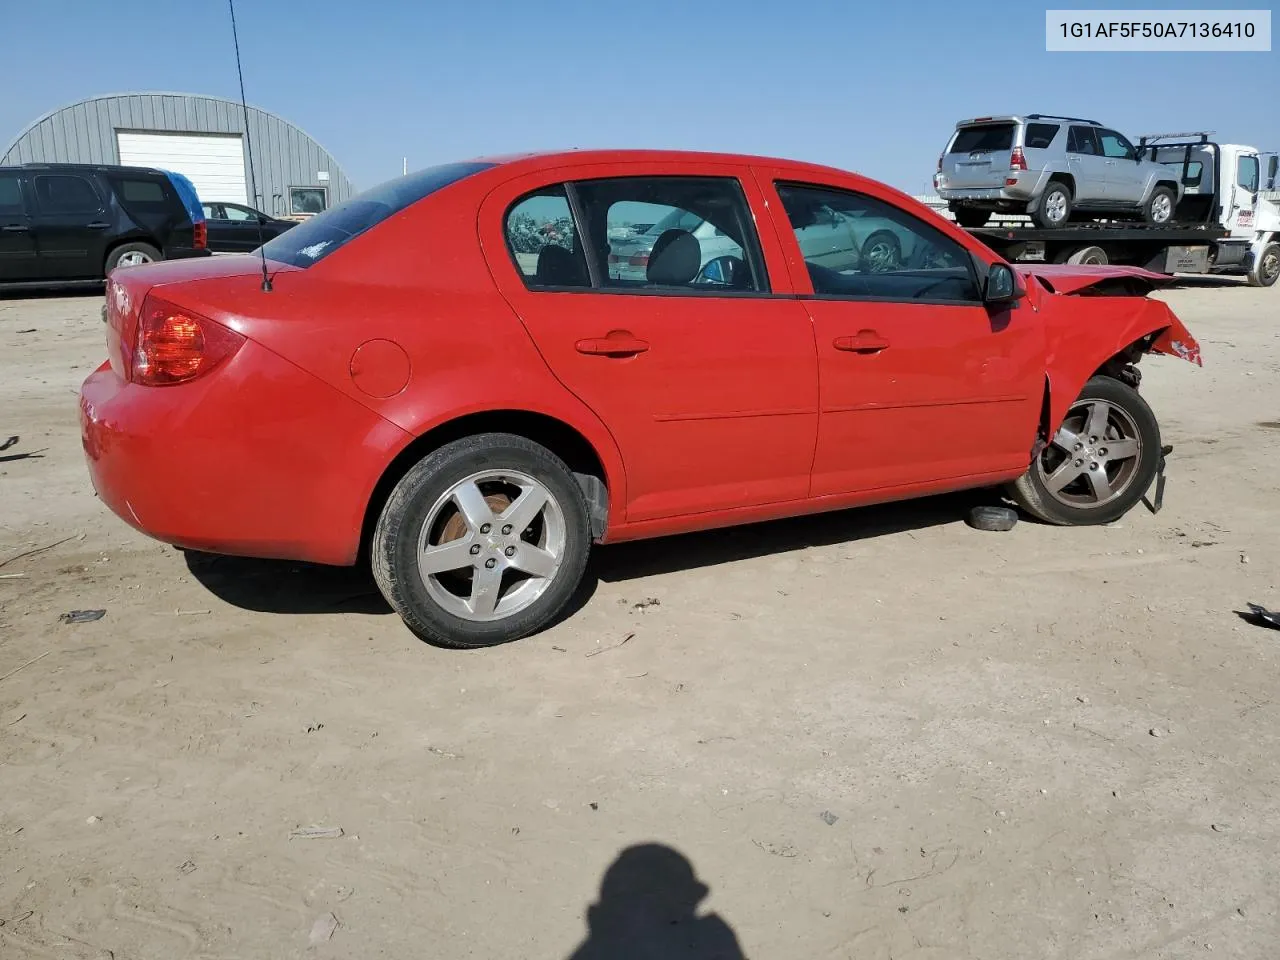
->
[184,490,996,622]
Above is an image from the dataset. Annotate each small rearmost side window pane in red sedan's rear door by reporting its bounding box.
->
[504,184,591,289]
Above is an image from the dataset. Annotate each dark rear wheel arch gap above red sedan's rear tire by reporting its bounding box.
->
[360,410,622,556]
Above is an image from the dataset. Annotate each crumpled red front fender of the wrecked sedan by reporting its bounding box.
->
[1041,294,1203,436]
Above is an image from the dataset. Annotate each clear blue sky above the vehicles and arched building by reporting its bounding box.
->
[0,0,1280,193]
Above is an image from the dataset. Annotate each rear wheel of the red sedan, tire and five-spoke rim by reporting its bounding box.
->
[371,434,591,649]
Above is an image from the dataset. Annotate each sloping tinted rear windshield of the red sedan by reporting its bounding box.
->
[262,163,493,268]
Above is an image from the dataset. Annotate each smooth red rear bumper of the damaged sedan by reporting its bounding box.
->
[81,340,410,564]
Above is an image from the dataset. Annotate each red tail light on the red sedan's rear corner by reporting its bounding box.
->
[129,296,244,387]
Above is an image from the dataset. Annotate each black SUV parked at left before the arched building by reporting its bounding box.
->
[0,164,209,287]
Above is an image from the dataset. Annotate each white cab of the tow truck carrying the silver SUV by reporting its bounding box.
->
[1138,133,1280,287]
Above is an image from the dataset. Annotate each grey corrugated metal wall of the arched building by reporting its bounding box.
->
[0,93,356,214]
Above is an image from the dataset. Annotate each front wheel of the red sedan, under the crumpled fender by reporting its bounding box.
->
[1009,376,1161,526]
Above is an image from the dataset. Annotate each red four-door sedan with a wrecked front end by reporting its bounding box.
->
[81,151,1199,646]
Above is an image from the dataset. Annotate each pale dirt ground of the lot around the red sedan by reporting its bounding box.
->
[0,283,1280,960]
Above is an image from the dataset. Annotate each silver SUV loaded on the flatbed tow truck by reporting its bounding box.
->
[933,114,1183,227]
